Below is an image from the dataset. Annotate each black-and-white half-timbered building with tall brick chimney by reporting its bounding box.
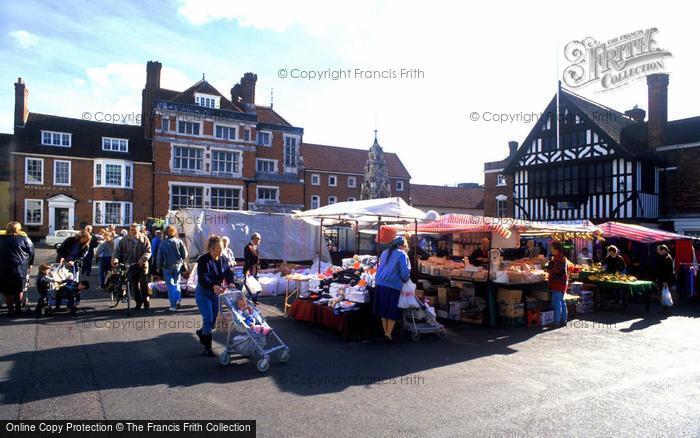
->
[484,74,700,233]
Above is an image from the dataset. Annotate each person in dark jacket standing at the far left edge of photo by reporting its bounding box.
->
[0,221,34,316]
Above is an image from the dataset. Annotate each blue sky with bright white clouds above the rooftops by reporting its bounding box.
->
[0,0,700,185]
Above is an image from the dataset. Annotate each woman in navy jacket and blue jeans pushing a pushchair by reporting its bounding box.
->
[194,235,233,356]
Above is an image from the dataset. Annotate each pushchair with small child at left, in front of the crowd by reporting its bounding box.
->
[36,263,90,316]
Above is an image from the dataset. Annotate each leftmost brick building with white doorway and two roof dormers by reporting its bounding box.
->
[9,78,153,237]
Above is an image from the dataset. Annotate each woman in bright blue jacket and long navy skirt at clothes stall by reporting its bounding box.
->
[374,236,411,342]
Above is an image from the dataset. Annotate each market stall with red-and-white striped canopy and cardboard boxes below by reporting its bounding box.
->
[388,214,599,326]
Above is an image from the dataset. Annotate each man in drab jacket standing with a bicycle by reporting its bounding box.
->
[112,223,151,310]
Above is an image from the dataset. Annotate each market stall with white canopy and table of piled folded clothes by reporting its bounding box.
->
[285,198,426,339]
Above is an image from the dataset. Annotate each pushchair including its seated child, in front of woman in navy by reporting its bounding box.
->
[219,290,289,372]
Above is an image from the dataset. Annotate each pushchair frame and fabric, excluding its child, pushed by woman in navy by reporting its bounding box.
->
[219,290,289,373]
